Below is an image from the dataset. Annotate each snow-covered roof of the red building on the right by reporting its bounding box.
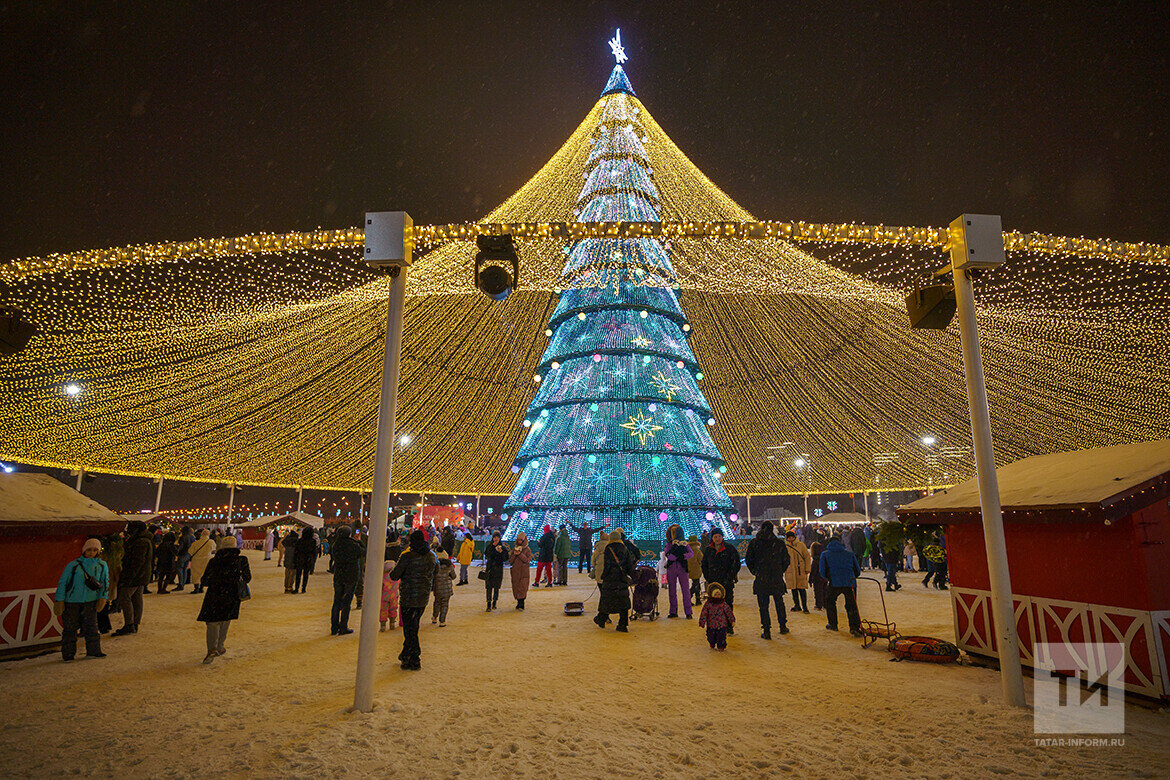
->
[897,439,1170,515]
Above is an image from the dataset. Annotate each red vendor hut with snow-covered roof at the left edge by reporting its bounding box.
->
[0,474,126,655]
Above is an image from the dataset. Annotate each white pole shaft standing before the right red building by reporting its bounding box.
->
[951,216,1025,706]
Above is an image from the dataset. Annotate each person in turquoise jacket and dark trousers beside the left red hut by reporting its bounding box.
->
[53,539,110,661]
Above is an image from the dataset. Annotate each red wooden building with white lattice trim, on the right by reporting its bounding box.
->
[897,440,1170,698]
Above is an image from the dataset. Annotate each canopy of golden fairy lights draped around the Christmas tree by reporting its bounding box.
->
[0,51,1170,495]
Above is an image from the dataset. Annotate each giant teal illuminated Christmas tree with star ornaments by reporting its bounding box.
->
[504,50,734,539]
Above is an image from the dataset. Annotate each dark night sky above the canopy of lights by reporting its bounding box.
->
[0,2,1170,260]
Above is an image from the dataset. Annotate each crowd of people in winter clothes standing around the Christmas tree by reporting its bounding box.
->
[55,520,947,670]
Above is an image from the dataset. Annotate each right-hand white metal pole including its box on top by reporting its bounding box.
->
[950,214,1025,706]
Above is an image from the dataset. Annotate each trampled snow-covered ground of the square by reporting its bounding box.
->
[0,552,1170,780]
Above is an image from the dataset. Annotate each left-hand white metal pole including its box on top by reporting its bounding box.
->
[353,212,413,712]
